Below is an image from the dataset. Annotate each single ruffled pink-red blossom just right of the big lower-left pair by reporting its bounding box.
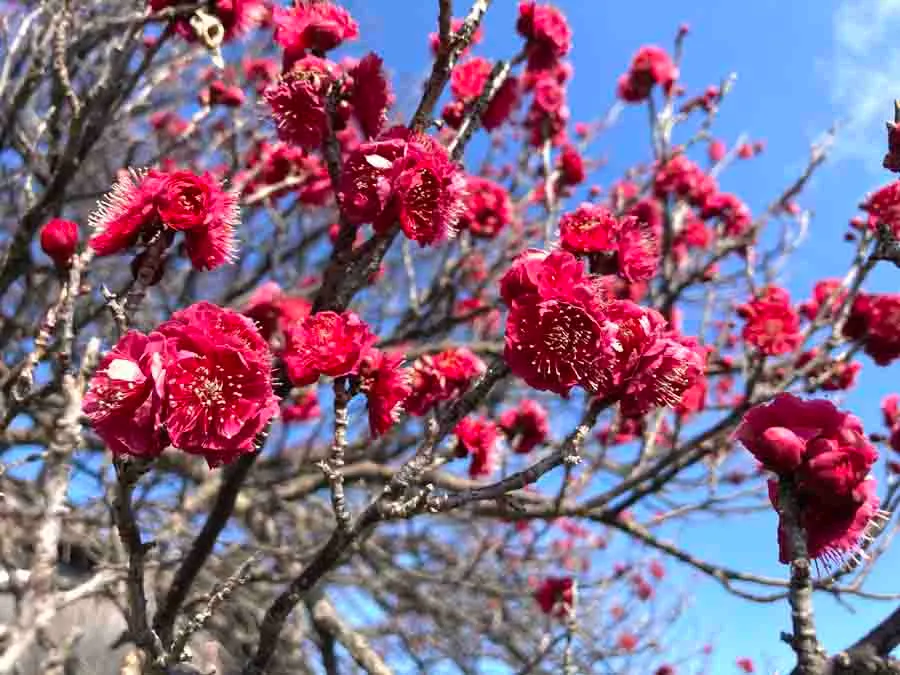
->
[284,311,378,387]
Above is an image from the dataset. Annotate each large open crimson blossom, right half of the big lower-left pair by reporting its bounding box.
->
[158,302,279,466]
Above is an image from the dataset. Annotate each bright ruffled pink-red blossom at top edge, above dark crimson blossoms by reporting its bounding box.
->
[273,0,359,66]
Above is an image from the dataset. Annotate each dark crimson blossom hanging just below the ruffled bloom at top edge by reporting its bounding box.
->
[263,56,336,150]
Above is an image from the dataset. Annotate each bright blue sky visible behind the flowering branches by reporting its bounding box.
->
[344,0,900,674]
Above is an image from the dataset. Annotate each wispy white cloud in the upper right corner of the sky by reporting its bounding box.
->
[823,0,900,172]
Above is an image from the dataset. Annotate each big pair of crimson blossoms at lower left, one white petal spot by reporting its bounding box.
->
[83,302,279,466]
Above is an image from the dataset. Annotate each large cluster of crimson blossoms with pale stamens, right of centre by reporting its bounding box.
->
[500,250,705,415]
